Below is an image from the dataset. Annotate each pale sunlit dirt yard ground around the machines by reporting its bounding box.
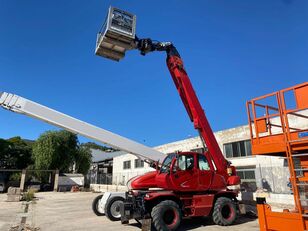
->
[0,192,259,231]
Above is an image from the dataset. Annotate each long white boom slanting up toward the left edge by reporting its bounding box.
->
[0,92,166,161]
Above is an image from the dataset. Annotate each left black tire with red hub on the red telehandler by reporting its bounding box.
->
[151,200,182,231]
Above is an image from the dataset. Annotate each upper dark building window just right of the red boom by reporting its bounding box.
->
[224,140,251,158]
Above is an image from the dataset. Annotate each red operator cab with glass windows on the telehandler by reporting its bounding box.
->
[156,152,225,191]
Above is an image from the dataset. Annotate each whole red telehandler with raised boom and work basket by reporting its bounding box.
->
[96,7,240,231]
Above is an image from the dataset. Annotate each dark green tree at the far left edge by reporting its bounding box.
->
[0,136,33,169]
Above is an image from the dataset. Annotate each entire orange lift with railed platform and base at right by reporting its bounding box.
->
[247,82,308,231]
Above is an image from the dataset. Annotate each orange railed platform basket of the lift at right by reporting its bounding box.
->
[247,83,308,156]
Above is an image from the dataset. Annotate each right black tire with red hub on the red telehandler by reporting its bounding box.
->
[212,197,237,226]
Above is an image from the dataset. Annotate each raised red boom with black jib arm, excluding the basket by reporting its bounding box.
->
[137,39,231,179]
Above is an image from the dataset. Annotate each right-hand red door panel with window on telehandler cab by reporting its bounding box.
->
[197,154,214,190]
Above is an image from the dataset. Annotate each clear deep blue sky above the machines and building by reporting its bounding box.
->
[0,0,308,146]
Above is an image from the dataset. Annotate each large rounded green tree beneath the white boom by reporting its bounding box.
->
[33,130,91,174]
